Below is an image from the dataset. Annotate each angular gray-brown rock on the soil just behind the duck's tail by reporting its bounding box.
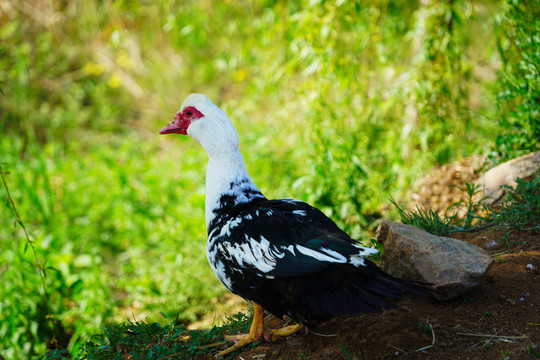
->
[377,220,493,300]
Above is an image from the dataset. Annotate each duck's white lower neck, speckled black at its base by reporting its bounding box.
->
[205,151,264,229]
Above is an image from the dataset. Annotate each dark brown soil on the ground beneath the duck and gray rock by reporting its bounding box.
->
[220,230,540,360]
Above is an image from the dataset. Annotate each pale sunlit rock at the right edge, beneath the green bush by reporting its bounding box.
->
[473,151,540,205]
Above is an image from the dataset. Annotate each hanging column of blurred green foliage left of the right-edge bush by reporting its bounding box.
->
[413,0,473,164]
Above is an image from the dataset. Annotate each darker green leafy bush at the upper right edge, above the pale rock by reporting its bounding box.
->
[495,0,540,161]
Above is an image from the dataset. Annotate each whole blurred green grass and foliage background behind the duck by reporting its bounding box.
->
[0,0,540,359]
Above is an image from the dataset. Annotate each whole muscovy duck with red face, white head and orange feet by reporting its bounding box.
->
[160,94,423,356]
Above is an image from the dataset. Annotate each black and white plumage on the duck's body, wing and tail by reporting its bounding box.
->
[207,197,420,326]
